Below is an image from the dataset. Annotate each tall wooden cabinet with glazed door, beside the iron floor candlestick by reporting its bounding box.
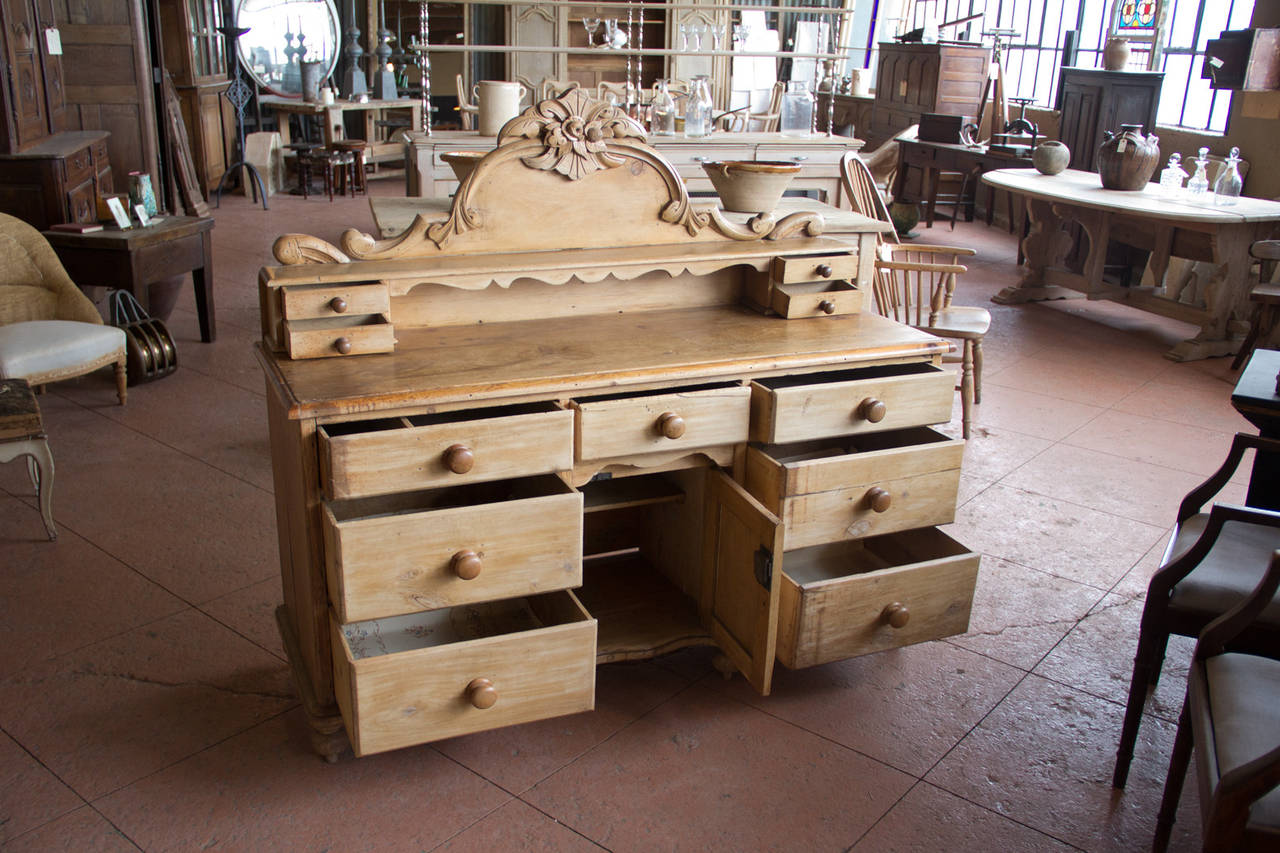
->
[160,0,236,191]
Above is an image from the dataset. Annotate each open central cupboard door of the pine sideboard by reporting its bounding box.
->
[703,471,782,695]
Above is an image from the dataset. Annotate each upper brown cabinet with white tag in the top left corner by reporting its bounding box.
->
[0,0,67,154]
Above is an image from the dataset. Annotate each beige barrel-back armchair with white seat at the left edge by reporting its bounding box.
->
[0,214,125,406]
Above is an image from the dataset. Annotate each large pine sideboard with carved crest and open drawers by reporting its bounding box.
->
[259,91,978,760]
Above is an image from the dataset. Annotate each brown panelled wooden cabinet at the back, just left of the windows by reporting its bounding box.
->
[865,42,991,147]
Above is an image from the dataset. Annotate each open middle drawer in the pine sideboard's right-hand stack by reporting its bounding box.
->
[746,427,964,548]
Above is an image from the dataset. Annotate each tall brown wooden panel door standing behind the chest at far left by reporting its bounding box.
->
[54,0,160,184]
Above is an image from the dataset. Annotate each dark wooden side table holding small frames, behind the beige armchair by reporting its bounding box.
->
[42,216,216,343]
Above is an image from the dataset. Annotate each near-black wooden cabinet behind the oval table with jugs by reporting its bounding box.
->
[1056,68,1165,172]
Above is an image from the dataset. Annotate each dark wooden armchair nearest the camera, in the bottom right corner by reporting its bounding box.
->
[1152,551,1280,853]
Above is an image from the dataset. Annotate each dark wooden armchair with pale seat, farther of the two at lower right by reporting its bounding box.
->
[1112,433,1280,788]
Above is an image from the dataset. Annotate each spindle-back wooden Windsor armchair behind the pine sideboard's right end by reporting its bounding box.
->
[840,151,991,438]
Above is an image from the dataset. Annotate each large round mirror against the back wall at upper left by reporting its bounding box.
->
[236,0,342,97]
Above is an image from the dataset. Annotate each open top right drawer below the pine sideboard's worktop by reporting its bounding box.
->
[751,364,955,444]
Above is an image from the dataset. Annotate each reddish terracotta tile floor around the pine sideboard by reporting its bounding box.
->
[0,179,1248,853]
